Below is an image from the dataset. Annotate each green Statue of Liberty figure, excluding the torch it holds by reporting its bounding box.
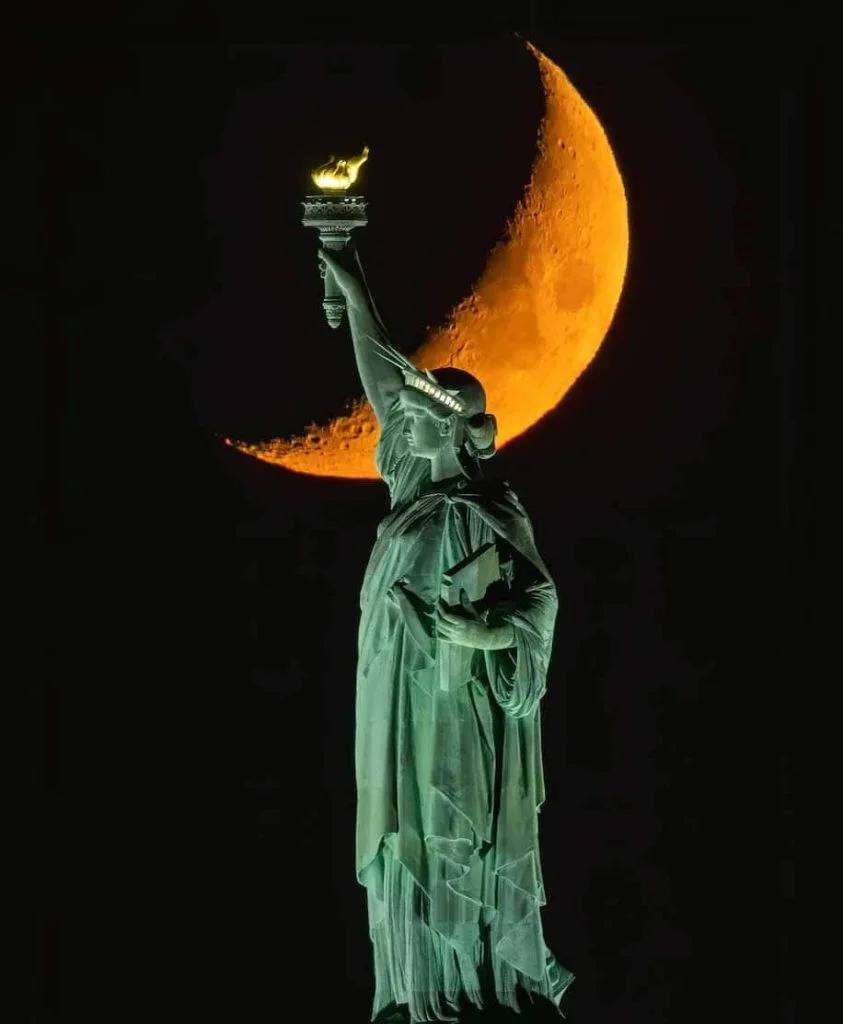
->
[319,243,574,1022]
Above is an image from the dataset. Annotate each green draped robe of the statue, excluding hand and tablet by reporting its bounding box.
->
[355,402,574,1020]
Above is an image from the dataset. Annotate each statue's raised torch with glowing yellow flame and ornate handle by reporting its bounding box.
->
[301,145,369,328]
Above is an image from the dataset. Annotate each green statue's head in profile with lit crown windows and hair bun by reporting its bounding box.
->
[398,367,497,468]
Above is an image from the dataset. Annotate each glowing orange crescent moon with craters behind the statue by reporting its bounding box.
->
[226,42,629,479]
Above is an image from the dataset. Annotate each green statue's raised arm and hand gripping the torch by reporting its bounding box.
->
[319,246,405,425]
